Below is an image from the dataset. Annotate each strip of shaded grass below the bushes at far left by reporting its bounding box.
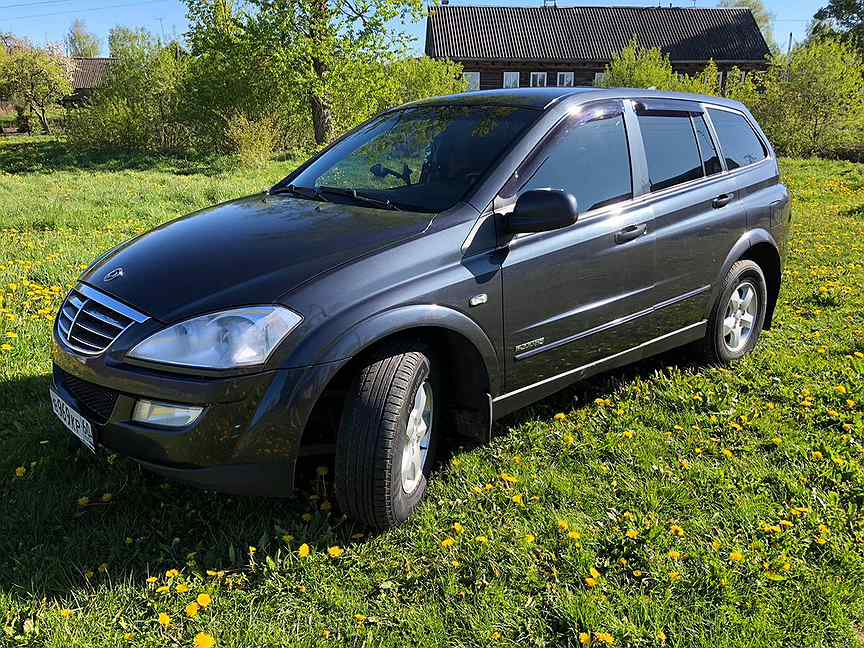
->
[0,137,227,176]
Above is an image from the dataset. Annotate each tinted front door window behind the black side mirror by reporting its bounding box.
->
[522,115,633,212]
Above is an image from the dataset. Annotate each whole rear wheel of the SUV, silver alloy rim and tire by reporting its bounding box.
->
[703,260,768,364]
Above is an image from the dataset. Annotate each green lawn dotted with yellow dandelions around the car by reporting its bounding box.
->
[0,139,864,648]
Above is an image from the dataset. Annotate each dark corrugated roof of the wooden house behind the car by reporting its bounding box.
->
[426,5,769,63]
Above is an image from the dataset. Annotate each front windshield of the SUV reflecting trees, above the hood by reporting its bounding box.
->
[274,105,539,212]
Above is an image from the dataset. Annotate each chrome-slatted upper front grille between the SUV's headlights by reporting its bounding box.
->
[57,284,147,355]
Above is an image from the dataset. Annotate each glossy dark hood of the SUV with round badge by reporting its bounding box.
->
[81,195,432,322]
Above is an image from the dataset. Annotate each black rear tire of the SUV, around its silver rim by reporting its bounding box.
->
[702,259,768,364]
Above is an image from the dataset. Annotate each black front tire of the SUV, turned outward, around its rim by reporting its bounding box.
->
[335,342,440,529]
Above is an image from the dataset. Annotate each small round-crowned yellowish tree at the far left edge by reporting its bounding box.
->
[0,46,72,133]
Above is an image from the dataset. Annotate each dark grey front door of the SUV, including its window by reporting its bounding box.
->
[502,102,655,392]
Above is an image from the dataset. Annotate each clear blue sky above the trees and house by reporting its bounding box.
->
[6,0,827,54]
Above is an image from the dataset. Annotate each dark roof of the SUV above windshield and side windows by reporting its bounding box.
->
[409,88,743,110]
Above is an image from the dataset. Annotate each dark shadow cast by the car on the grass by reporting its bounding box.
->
[0,344,699,598]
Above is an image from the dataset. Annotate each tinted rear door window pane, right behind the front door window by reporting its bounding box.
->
[639,114,703,191]
